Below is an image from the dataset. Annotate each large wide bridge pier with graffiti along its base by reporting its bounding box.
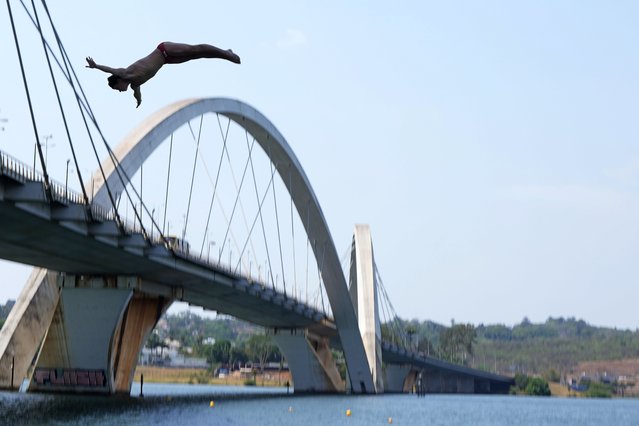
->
[20,274,172,394]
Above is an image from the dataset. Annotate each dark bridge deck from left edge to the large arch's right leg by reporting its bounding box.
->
[0,153,339,344]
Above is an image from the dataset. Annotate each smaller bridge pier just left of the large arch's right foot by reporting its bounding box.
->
[272,329,345,393]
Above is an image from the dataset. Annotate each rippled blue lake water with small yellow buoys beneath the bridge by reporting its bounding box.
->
[0,384,639,426]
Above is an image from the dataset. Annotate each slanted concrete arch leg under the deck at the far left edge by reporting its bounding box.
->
[0,268,60,389]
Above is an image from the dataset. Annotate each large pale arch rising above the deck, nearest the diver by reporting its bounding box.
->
[92,98,375,393]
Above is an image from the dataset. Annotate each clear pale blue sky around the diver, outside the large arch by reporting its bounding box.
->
[0,0,639,329]
